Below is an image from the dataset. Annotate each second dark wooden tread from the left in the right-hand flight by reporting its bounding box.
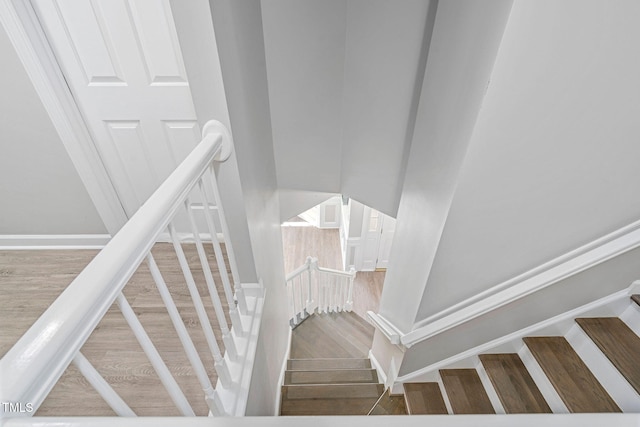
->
[440,369,495,414]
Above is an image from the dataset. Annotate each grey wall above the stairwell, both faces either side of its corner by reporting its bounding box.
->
[262,0,431,216]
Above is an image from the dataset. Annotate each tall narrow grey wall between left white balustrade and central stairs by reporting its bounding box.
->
[210,0,289,415]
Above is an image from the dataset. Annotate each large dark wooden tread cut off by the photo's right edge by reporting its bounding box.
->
[576,317,640,394]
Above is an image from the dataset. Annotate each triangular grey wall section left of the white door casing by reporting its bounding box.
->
[0,22,106,234]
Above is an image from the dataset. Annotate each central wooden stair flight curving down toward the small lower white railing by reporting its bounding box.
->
[280,312,384,415]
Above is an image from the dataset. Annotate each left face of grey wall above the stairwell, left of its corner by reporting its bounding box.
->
[262,0,346,193]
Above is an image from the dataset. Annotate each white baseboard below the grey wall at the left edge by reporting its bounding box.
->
[0,234,111,251]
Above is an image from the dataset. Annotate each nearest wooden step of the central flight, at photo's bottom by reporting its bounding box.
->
[280,384,384,415]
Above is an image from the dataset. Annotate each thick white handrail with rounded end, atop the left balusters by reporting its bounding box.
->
[0,121,260,417]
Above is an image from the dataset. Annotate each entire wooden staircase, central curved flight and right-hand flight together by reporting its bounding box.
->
[280,295,640,415]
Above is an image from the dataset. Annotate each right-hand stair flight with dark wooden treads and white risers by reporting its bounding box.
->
[403,295,640,414]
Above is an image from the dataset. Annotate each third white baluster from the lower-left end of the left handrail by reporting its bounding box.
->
[147,254,225,415]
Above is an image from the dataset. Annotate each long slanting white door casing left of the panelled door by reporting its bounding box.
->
[0,0,127,234]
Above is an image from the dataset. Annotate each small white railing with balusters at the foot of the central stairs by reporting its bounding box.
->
[286,257,356,328]
